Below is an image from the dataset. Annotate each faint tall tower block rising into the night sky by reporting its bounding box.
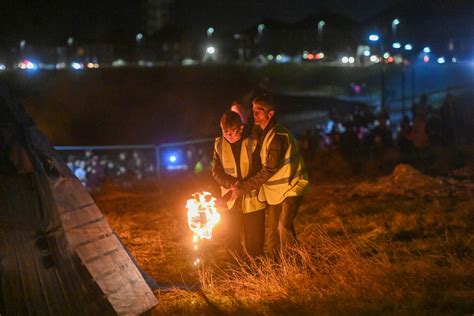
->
[144,0,174,36]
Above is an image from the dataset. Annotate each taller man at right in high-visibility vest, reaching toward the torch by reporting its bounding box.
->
[231,95,309,258]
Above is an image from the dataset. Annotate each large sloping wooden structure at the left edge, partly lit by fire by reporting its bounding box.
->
[0,86,157,315]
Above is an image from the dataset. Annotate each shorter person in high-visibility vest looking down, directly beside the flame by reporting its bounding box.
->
[211,111,265,257]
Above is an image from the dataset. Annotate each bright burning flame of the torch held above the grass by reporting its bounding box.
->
[186,192,221,242]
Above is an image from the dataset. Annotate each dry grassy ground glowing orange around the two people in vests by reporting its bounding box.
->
[94,166,474,315]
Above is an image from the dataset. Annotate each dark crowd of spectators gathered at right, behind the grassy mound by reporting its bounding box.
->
[298,92,472,174]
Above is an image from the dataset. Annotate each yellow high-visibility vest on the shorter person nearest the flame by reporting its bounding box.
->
[214,137,265,213]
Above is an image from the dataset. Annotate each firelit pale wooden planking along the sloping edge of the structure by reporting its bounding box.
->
[52,178,158,314]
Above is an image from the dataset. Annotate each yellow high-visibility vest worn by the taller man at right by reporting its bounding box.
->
[258,124,309,205]
